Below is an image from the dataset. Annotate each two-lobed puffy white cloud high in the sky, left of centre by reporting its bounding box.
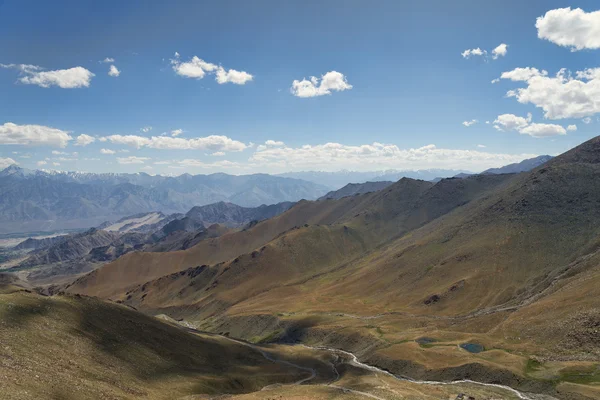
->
[171,52,254,85]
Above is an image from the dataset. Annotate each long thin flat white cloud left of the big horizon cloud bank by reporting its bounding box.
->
[104,135,247,151]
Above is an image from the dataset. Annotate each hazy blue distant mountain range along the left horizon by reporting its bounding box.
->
[0,165,327,233]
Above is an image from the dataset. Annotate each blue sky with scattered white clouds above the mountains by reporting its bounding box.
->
[0,0,600,175]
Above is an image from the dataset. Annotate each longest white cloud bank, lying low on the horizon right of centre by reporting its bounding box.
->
[249,142,534,171]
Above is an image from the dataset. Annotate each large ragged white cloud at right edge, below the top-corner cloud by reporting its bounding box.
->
[502,68,600,119]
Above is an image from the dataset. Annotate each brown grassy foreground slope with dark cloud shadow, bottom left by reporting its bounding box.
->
[0,287,314,399]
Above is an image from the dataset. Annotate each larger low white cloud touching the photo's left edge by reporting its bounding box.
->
[0,122,72,147]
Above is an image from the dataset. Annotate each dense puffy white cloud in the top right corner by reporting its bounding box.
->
[535,7,600,51]
